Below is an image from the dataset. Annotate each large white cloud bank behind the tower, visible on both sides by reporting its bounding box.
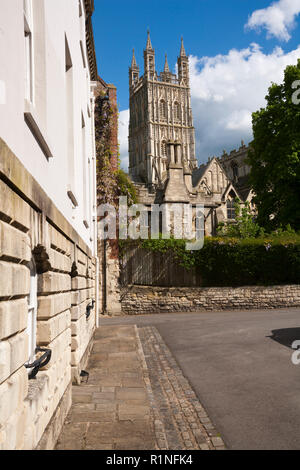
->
[119,44,300,170]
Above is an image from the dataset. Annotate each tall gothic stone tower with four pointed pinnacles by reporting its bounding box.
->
[129,31,197,187]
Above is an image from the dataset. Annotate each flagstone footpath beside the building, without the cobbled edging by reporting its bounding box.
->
[56,326,155,450]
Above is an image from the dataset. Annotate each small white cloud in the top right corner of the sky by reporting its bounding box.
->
[246,0,300,41]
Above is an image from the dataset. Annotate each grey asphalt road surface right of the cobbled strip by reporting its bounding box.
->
[100,309,300,450]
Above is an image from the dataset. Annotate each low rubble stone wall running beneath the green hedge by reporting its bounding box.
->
[121,285,300,315]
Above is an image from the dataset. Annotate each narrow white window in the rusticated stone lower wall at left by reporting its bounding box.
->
[26,260,37,373]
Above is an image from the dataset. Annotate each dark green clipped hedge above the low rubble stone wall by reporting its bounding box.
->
[122,236,300,287]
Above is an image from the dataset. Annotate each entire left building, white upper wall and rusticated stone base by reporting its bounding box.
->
[0,0,98,450]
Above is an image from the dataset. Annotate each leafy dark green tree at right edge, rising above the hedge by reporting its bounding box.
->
[248,60,300,231]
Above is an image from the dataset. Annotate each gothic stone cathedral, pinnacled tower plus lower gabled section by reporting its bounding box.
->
[129,32,251,235]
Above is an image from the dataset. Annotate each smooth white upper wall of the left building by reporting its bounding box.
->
[0,0,95,253]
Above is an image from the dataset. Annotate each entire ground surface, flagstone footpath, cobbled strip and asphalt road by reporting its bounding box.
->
[57,308,300,450]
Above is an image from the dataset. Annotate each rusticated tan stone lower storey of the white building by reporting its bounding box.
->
[0,139,96,450]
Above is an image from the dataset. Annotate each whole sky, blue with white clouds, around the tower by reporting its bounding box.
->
[93,0,300,169]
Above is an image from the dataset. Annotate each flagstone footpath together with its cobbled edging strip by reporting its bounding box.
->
[56,325,225,450]
